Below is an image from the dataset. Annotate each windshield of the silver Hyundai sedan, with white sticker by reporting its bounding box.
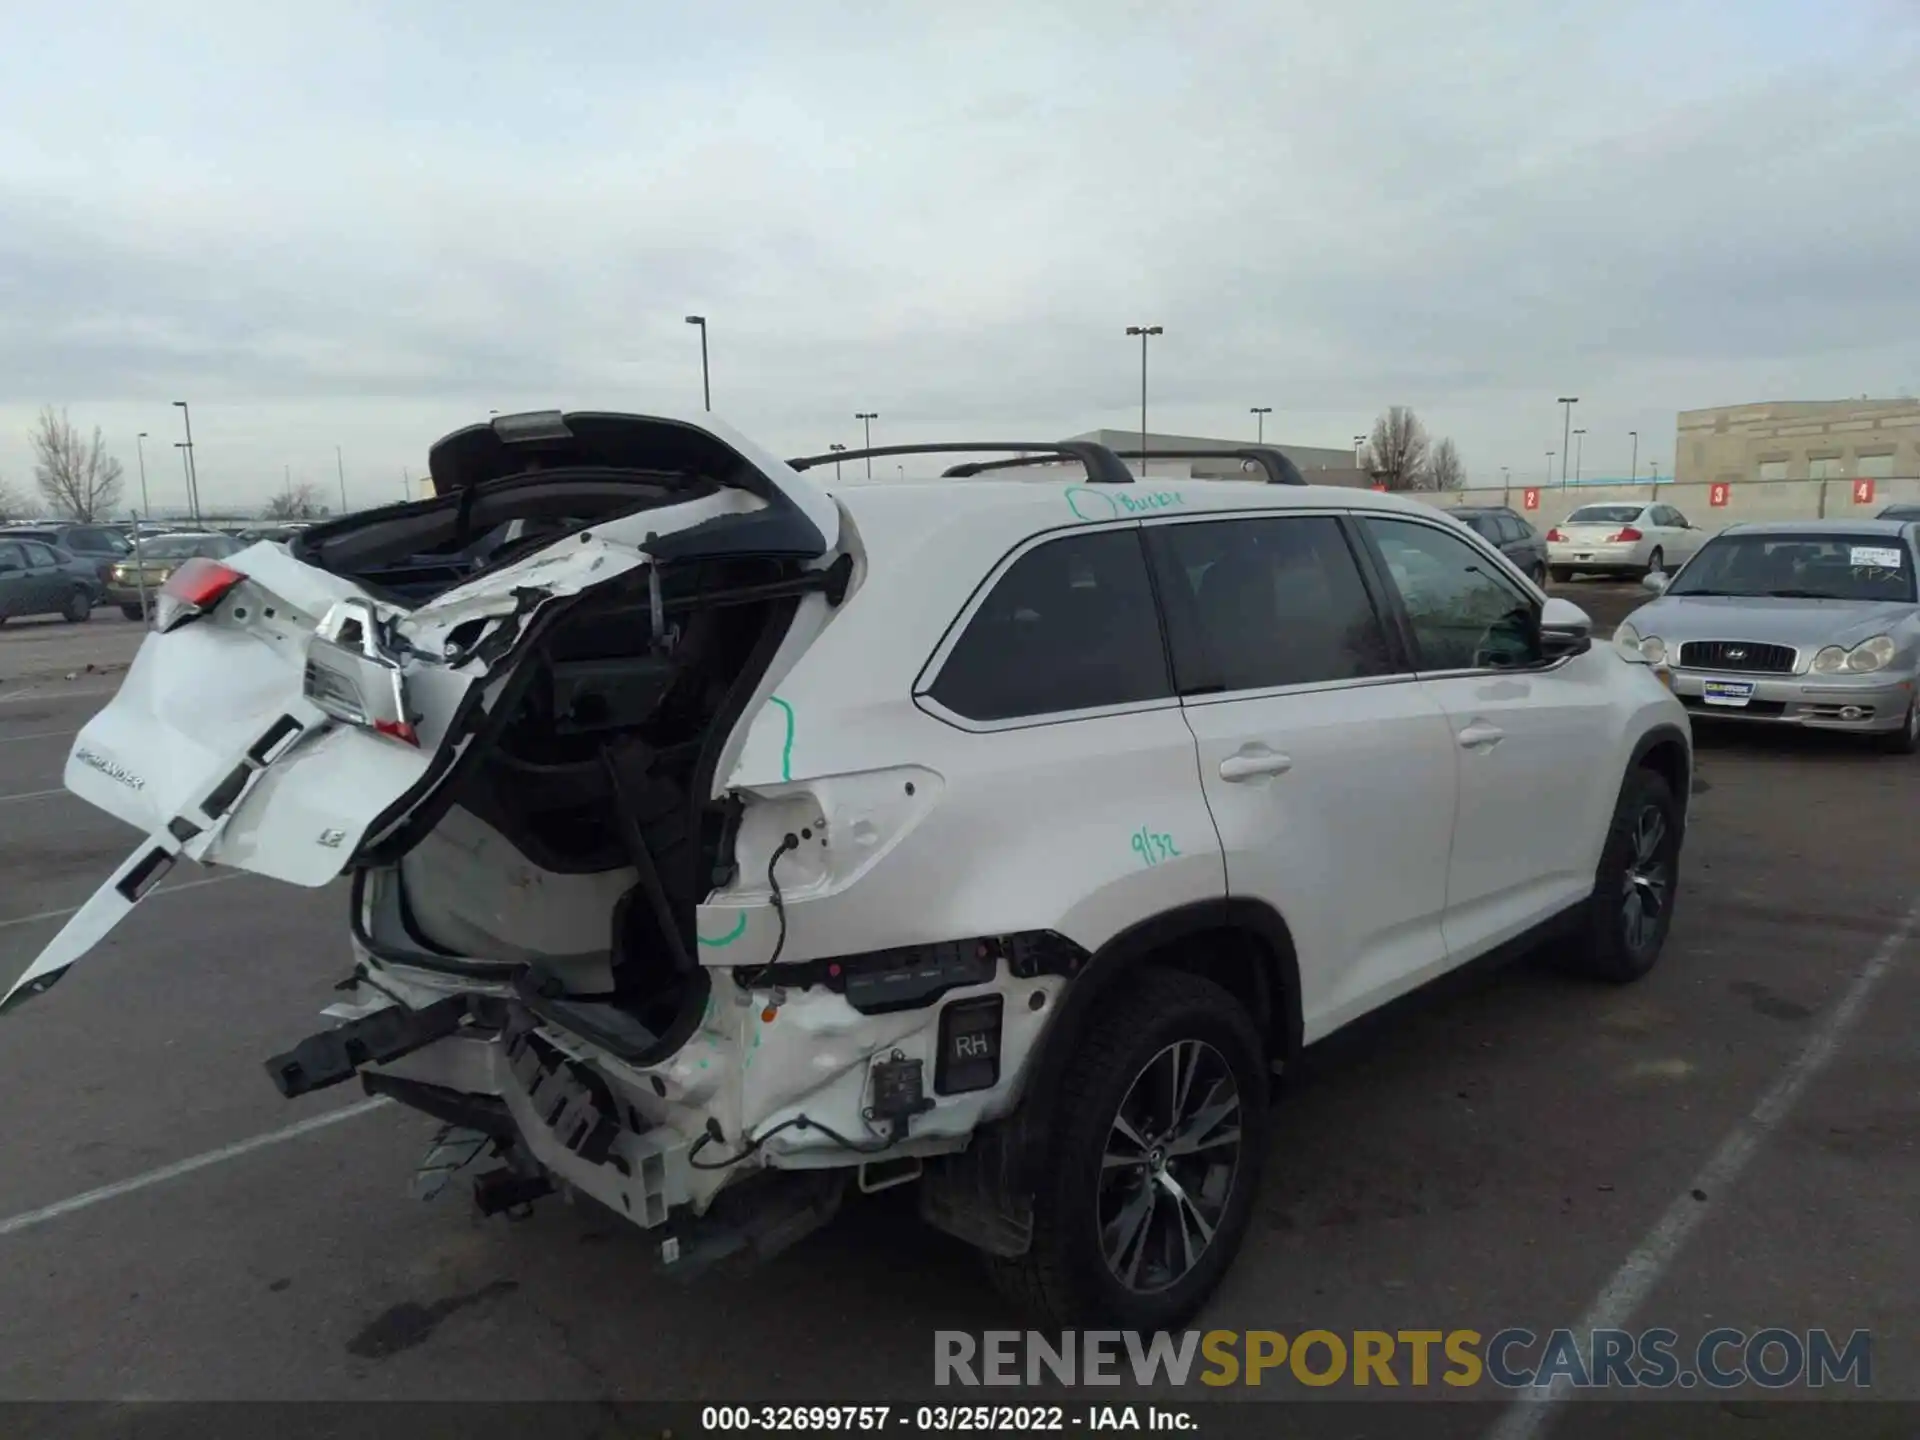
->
[1667,534,1914,601]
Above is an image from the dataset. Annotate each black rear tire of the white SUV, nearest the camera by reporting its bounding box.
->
[987,970,1267,1331]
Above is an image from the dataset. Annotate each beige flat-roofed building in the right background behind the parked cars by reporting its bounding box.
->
[1674,399,1920,486]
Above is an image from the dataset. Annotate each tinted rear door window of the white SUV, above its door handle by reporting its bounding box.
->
[1148,516,1400,695]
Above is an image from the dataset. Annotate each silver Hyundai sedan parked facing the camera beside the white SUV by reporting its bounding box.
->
[1615,520,1920,755]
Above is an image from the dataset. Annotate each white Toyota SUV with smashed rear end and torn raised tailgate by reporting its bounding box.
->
[0,413,1692,1329]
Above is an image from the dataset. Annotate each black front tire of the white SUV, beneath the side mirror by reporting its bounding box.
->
[1567,768,1682,985]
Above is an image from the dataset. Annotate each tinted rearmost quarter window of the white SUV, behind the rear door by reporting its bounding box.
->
[927,530,1173,720]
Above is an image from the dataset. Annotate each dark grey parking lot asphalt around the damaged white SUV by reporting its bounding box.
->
[0,584,1920,1432]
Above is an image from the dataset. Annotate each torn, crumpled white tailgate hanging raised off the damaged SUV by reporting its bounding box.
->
[0,413,837,1010]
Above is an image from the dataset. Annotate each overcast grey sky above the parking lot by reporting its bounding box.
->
[0,0,1920,507]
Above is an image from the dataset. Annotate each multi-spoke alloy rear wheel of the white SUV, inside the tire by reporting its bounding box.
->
[1096,1041,1240,1294]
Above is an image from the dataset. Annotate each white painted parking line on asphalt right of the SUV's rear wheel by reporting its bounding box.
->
[1486,899,1920,1440]
